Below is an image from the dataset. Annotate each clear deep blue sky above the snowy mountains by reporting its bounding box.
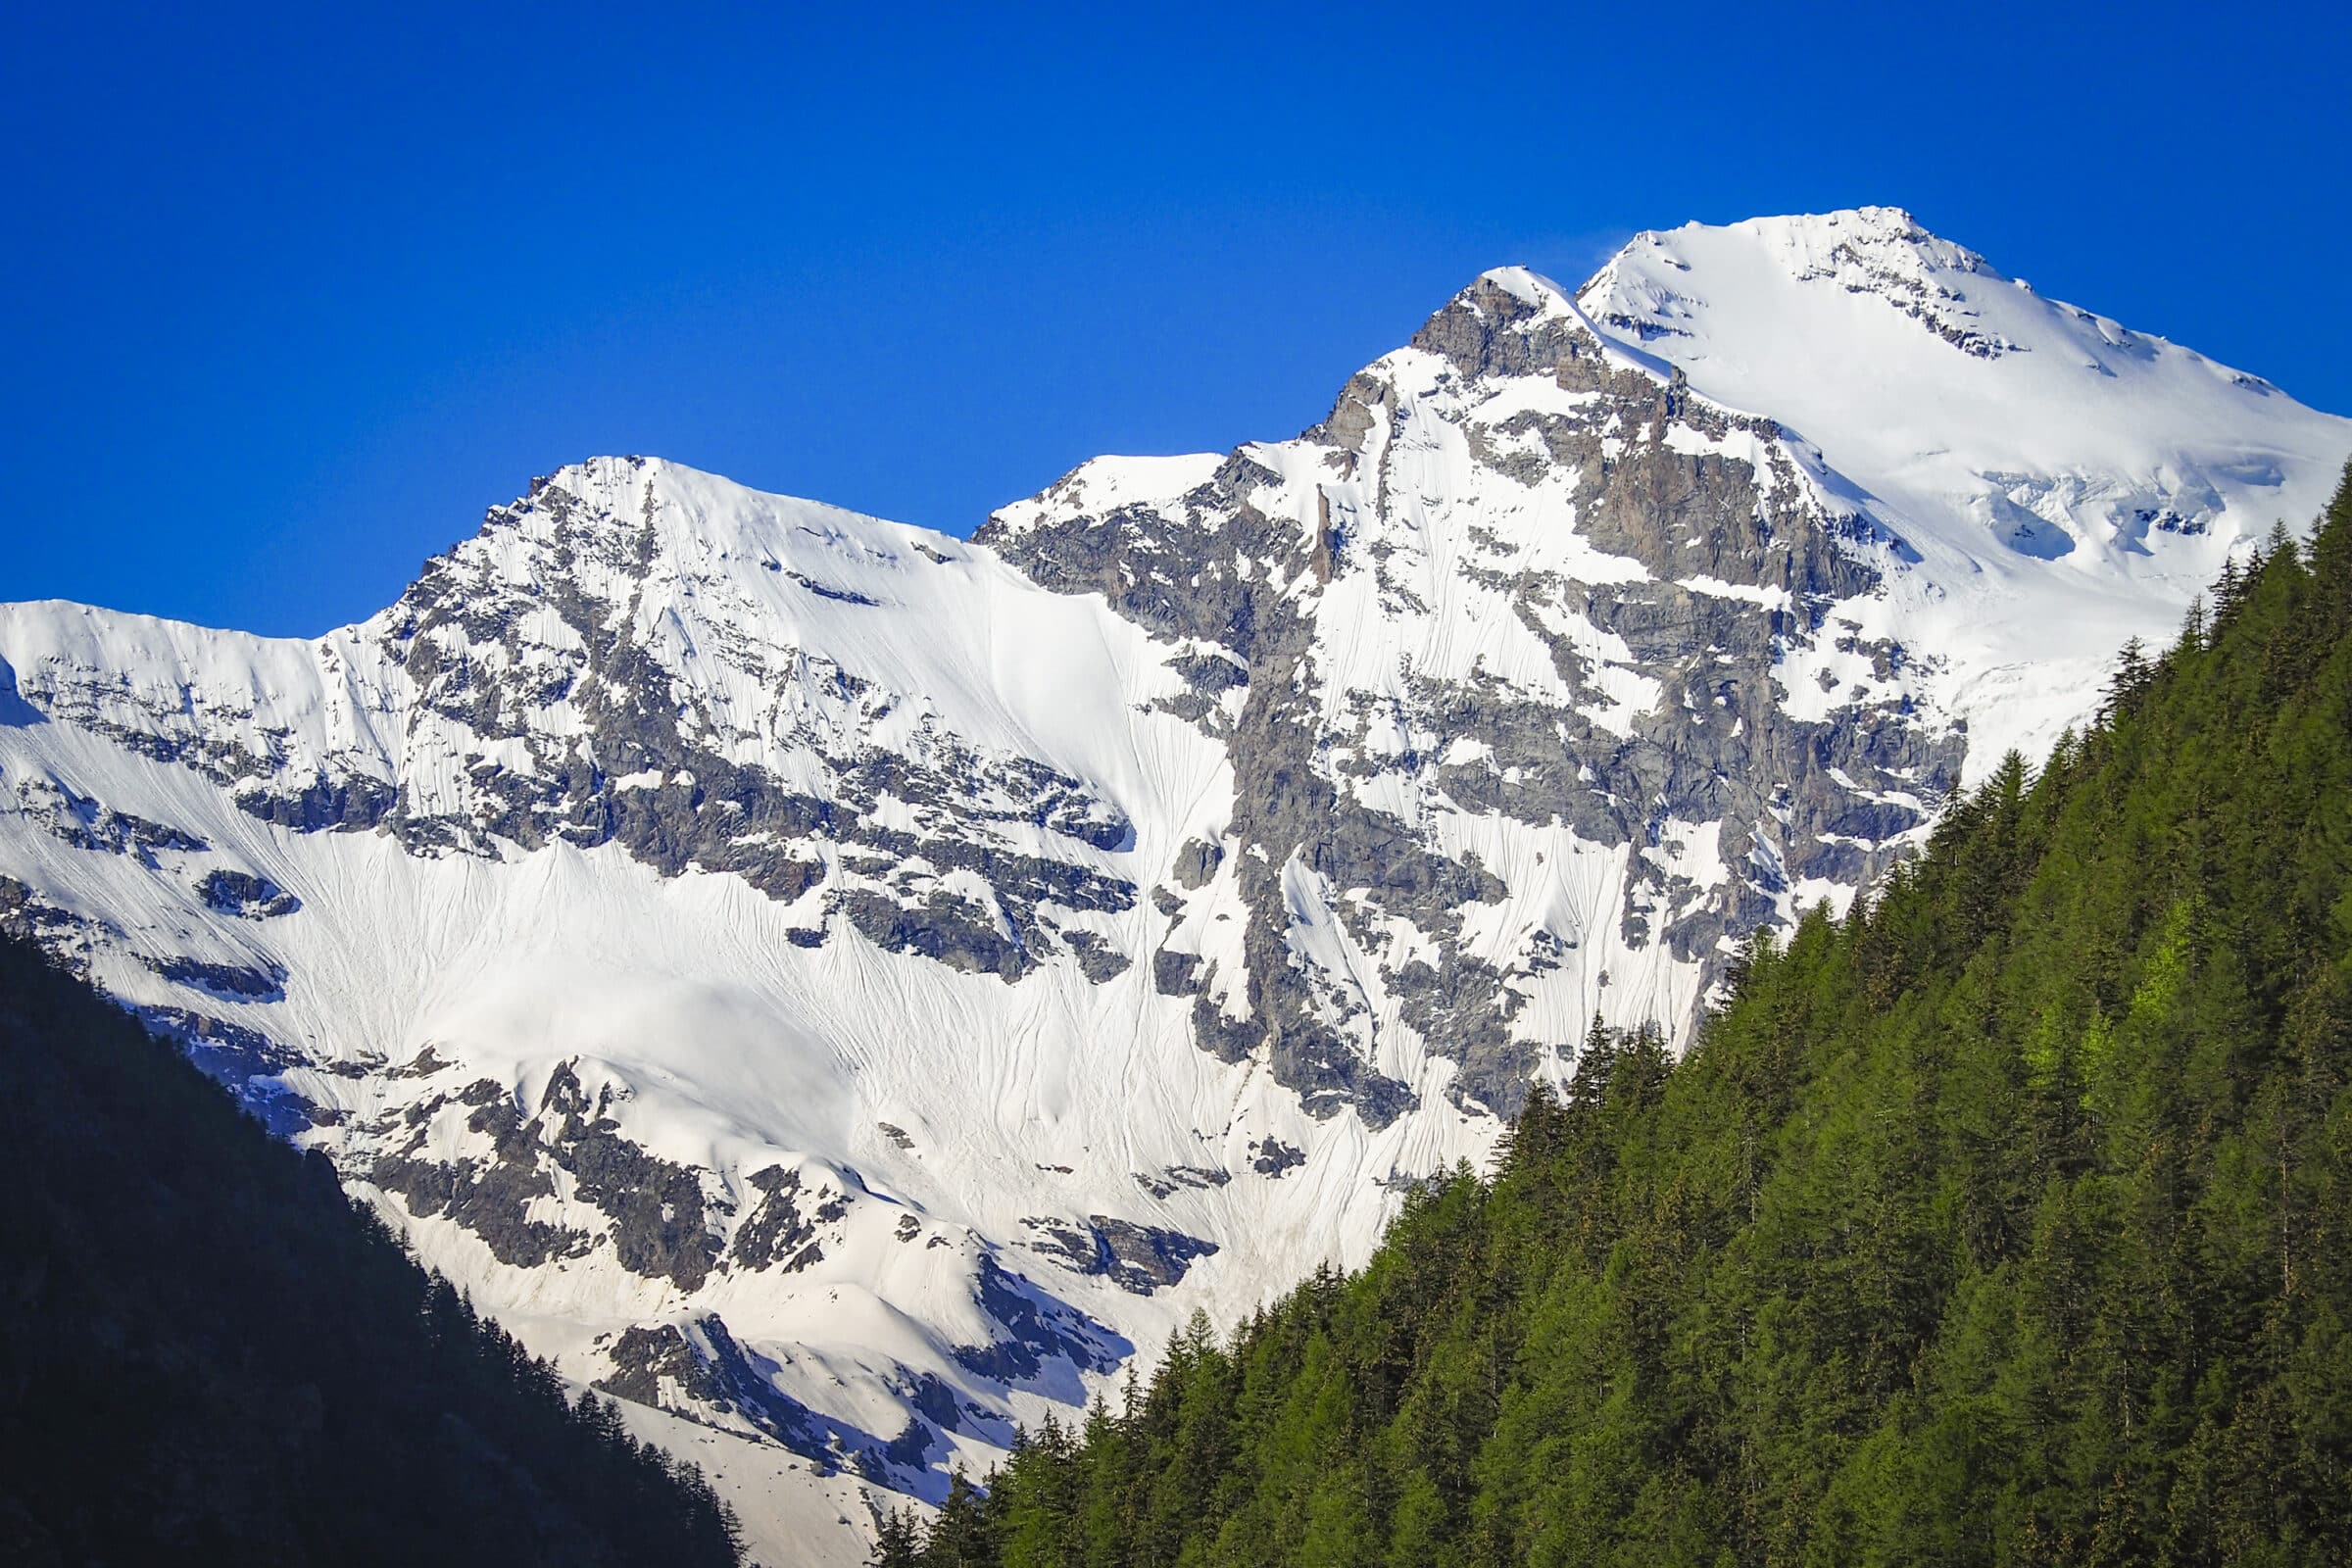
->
[0,0,2352,632]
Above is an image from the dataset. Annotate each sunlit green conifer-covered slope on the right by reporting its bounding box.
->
[877,475,2352,1568]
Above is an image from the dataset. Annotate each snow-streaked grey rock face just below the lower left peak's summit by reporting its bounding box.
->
[367,482,1136,980]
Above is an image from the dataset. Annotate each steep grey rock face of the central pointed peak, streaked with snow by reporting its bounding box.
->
[978,275,1964,1126]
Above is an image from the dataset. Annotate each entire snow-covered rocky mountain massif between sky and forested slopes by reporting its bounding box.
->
[0,209,2352,1556]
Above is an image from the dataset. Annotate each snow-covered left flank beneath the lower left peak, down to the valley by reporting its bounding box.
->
[0,461,1480,1560]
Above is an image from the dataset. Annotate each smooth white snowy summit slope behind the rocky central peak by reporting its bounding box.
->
[1578,207,2345,766]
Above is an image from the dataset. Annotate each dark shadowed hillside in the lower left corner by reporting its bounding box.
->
[0,938,739,1568]
